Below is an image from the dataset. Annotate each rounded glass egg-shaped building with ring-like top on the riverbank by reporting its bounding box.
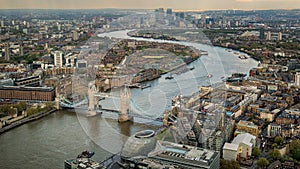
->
[121,130,156,159]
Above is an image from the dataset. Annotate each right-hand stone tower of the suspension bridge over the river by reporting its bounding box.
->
[118,86,131,123]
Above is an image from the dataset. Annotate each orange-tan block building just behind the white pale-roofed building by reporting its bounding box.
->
[234,120,259,137]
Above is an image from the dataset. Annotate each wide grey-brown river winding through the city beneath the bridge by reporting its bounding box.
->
[0,31,257,169]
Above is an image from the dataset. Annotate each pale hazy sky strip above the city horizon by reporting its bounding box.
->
[0,0,300,10]
